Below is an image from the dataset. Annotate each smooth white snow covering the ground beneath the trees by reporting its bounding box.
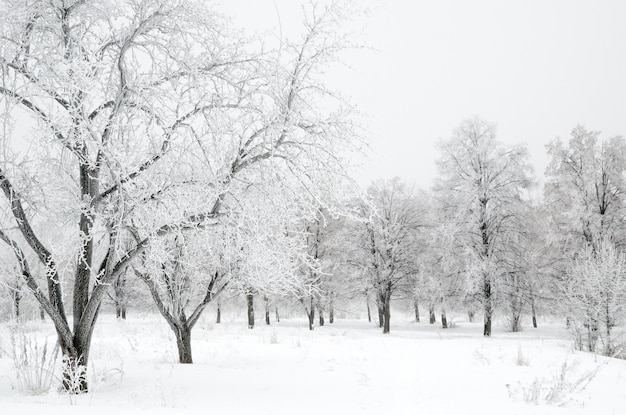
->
[0,315,626,415]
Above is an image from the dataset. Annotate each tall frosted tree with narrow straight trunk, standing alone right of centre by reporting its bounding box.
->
[435,117,530,336]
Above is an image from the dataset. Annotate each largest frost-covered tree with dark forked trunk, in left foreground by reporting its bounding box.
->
[0,0,353,393]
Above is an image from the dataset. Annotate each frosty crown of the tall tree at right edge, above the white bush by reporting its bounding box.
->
[545,125,626,253]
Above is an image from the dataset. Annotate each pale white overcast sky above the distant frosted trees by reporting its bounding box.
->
[219,0,626,187]
